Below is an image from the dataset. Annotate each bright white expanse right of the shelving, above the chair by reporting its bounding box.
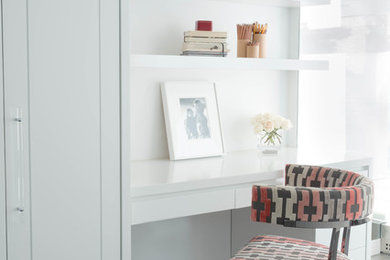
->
[299,0,390,177]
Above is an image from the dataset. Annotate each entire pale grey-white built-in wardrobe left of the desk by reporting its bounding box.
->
[0,0,121,260]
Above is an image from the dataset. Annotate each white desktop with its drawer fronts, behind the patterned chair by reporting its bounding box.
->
[131,148,371,224]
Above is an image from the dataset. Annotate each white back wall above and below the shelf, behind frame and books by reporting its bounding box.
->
[130,0,299,160]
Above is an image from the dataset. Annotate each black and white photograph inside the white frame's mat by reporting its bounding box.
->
[180,98,211,140]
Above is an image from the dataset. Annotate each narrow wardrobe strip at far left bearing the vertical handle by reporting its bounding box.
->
[2,0,31,260]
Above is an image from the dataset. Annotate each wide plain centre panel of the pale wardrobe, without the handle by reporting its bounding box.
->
[28,0,102,260]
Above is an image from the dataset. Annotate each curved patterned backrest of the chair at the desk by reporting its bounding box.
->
[251,165,373,225]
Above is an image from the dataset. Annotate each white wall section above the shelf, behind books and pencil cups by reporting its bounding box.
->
[130,0,298,58]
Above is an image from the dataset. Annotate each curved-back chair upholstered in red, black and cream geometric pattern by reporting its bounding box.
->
[232,165,373,260]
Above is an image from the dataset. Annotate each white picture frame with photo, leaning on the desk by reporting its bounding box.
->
[161,81,224,160]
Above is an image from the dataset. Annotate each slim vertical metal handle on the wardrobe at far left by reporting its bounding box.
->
[15,107,24,213]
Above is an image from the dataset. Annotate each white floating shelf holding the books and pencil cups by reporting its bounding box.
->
[130,55,329,70]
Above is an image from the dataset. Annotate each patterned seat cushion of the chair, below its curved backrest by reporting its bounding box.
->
[231,235,350,260]
